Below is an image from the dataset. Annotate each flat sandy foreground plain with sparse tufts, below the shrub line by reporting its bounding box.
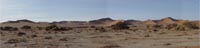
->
[0,30,200,48]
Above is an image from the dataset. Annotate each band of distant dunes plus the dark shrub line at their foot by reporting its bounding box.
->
[0,17,200,30]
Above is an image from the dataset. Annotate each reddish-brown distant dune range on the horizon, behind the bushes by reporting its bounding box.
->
[1,17,200,25]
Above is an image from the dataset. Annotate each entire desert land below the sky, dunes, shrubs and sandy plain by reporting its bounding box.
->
[0,17,200,48]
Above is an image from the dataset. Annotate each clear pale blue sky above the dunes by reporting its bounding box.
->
[0,0,200,22]
